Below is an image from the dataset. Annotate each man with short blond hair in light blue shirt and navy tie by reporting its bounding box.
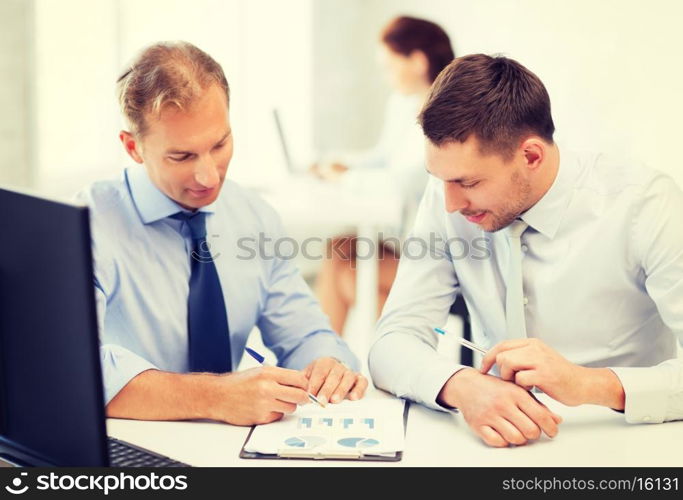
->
[79,42,367,425]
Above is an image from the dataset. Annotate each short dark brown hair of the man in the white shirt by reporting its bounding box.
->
[418,54,555,158]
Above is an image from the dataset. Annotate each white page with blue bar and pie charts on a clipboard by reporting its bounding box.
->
[244,397,405,458]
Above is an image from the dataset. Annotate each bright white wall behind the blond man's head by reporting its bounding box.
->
[29,0,312,194]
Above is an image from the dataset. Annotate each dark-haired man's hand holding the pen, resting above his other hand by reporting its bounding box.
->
[481,338,624,409]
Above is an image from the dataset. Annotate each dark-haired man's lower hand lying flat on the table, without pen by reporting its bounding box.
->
[437,368,562,447]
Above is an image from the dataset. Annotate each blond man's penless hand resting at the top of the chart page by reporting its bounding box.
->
[304,358,368,404]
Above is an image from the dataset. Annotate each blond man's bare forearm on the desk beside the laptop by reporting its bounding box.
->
[106,370,218,420]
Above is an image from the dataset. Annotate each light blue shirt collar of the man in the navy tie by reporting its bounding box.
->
[124,166,216,224]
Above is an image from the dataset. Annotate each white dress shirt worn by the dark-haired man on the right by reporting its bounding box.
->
[369,148,683,422]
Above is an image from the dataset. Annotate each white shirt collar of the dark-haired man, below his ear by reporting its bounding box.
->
[520,147,578,239]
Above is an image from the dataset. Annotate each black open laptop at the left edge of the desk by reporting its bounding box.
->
[0,188,186,467]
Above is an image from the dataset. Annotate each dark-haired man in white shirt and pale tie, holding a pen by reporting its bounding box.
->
[369,54,683,446]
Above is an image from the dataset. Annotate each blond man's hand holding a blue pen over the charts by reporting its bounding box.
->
[207,366,309,425]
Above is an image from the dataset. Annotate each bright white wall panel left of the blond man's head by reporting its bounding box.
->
[32,0,121,195]
